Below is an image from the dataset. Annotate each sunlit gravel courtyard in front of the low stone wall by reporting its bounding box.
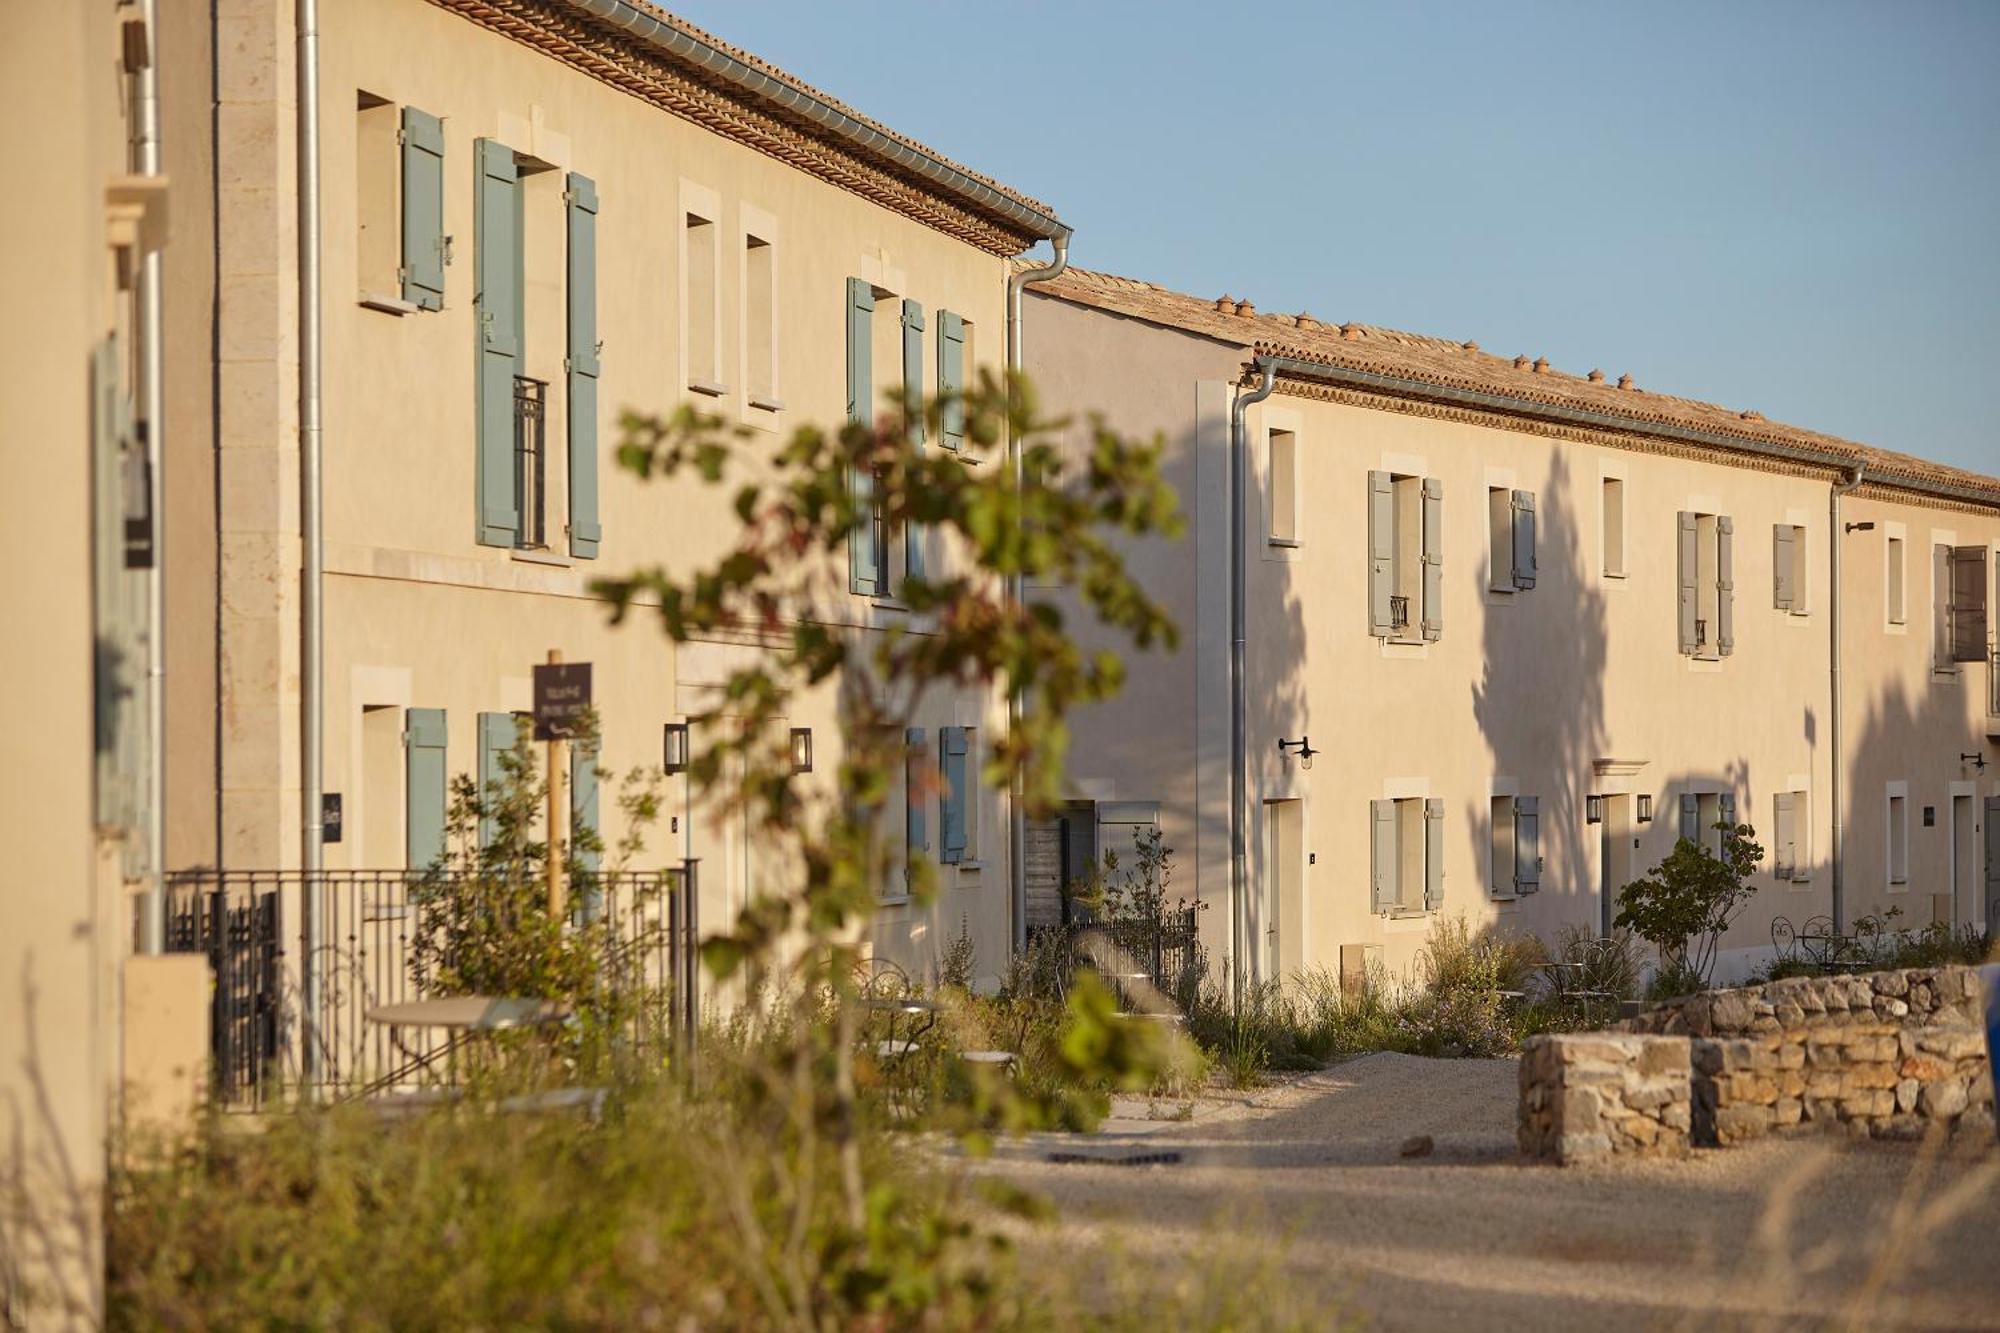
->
[980,1055,2000,1331]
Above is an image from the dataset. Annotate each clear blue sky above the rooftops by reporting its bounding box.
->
[666,0,2000,474]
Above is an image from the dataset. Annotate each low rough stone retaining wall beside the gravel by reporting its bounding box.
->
[1520,967,1994,1161]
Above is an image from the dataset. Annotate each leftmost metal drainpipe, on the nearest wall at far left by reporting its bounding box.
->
[132,0,166,953]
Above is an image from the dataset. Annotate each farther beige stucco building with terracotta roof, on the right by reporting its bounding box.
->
[1026,270,2000,977]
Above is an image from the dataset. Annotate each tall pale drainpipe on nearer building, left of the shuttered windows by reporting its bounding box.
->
[294,0,326,1097]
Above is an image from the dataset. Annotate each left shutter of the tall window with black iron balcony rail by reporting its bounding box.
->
[472,138,522,546]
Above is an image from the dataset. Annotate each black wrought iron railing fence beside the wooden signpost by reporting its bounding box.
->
[166,861,700,1107]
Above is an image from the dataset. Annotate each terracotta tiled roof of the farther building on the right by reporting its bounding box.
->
[1032,268,2000,506]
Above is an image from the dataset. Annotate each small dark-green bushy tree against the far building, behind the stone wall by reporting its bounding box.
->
[1612,821,1764,987]
